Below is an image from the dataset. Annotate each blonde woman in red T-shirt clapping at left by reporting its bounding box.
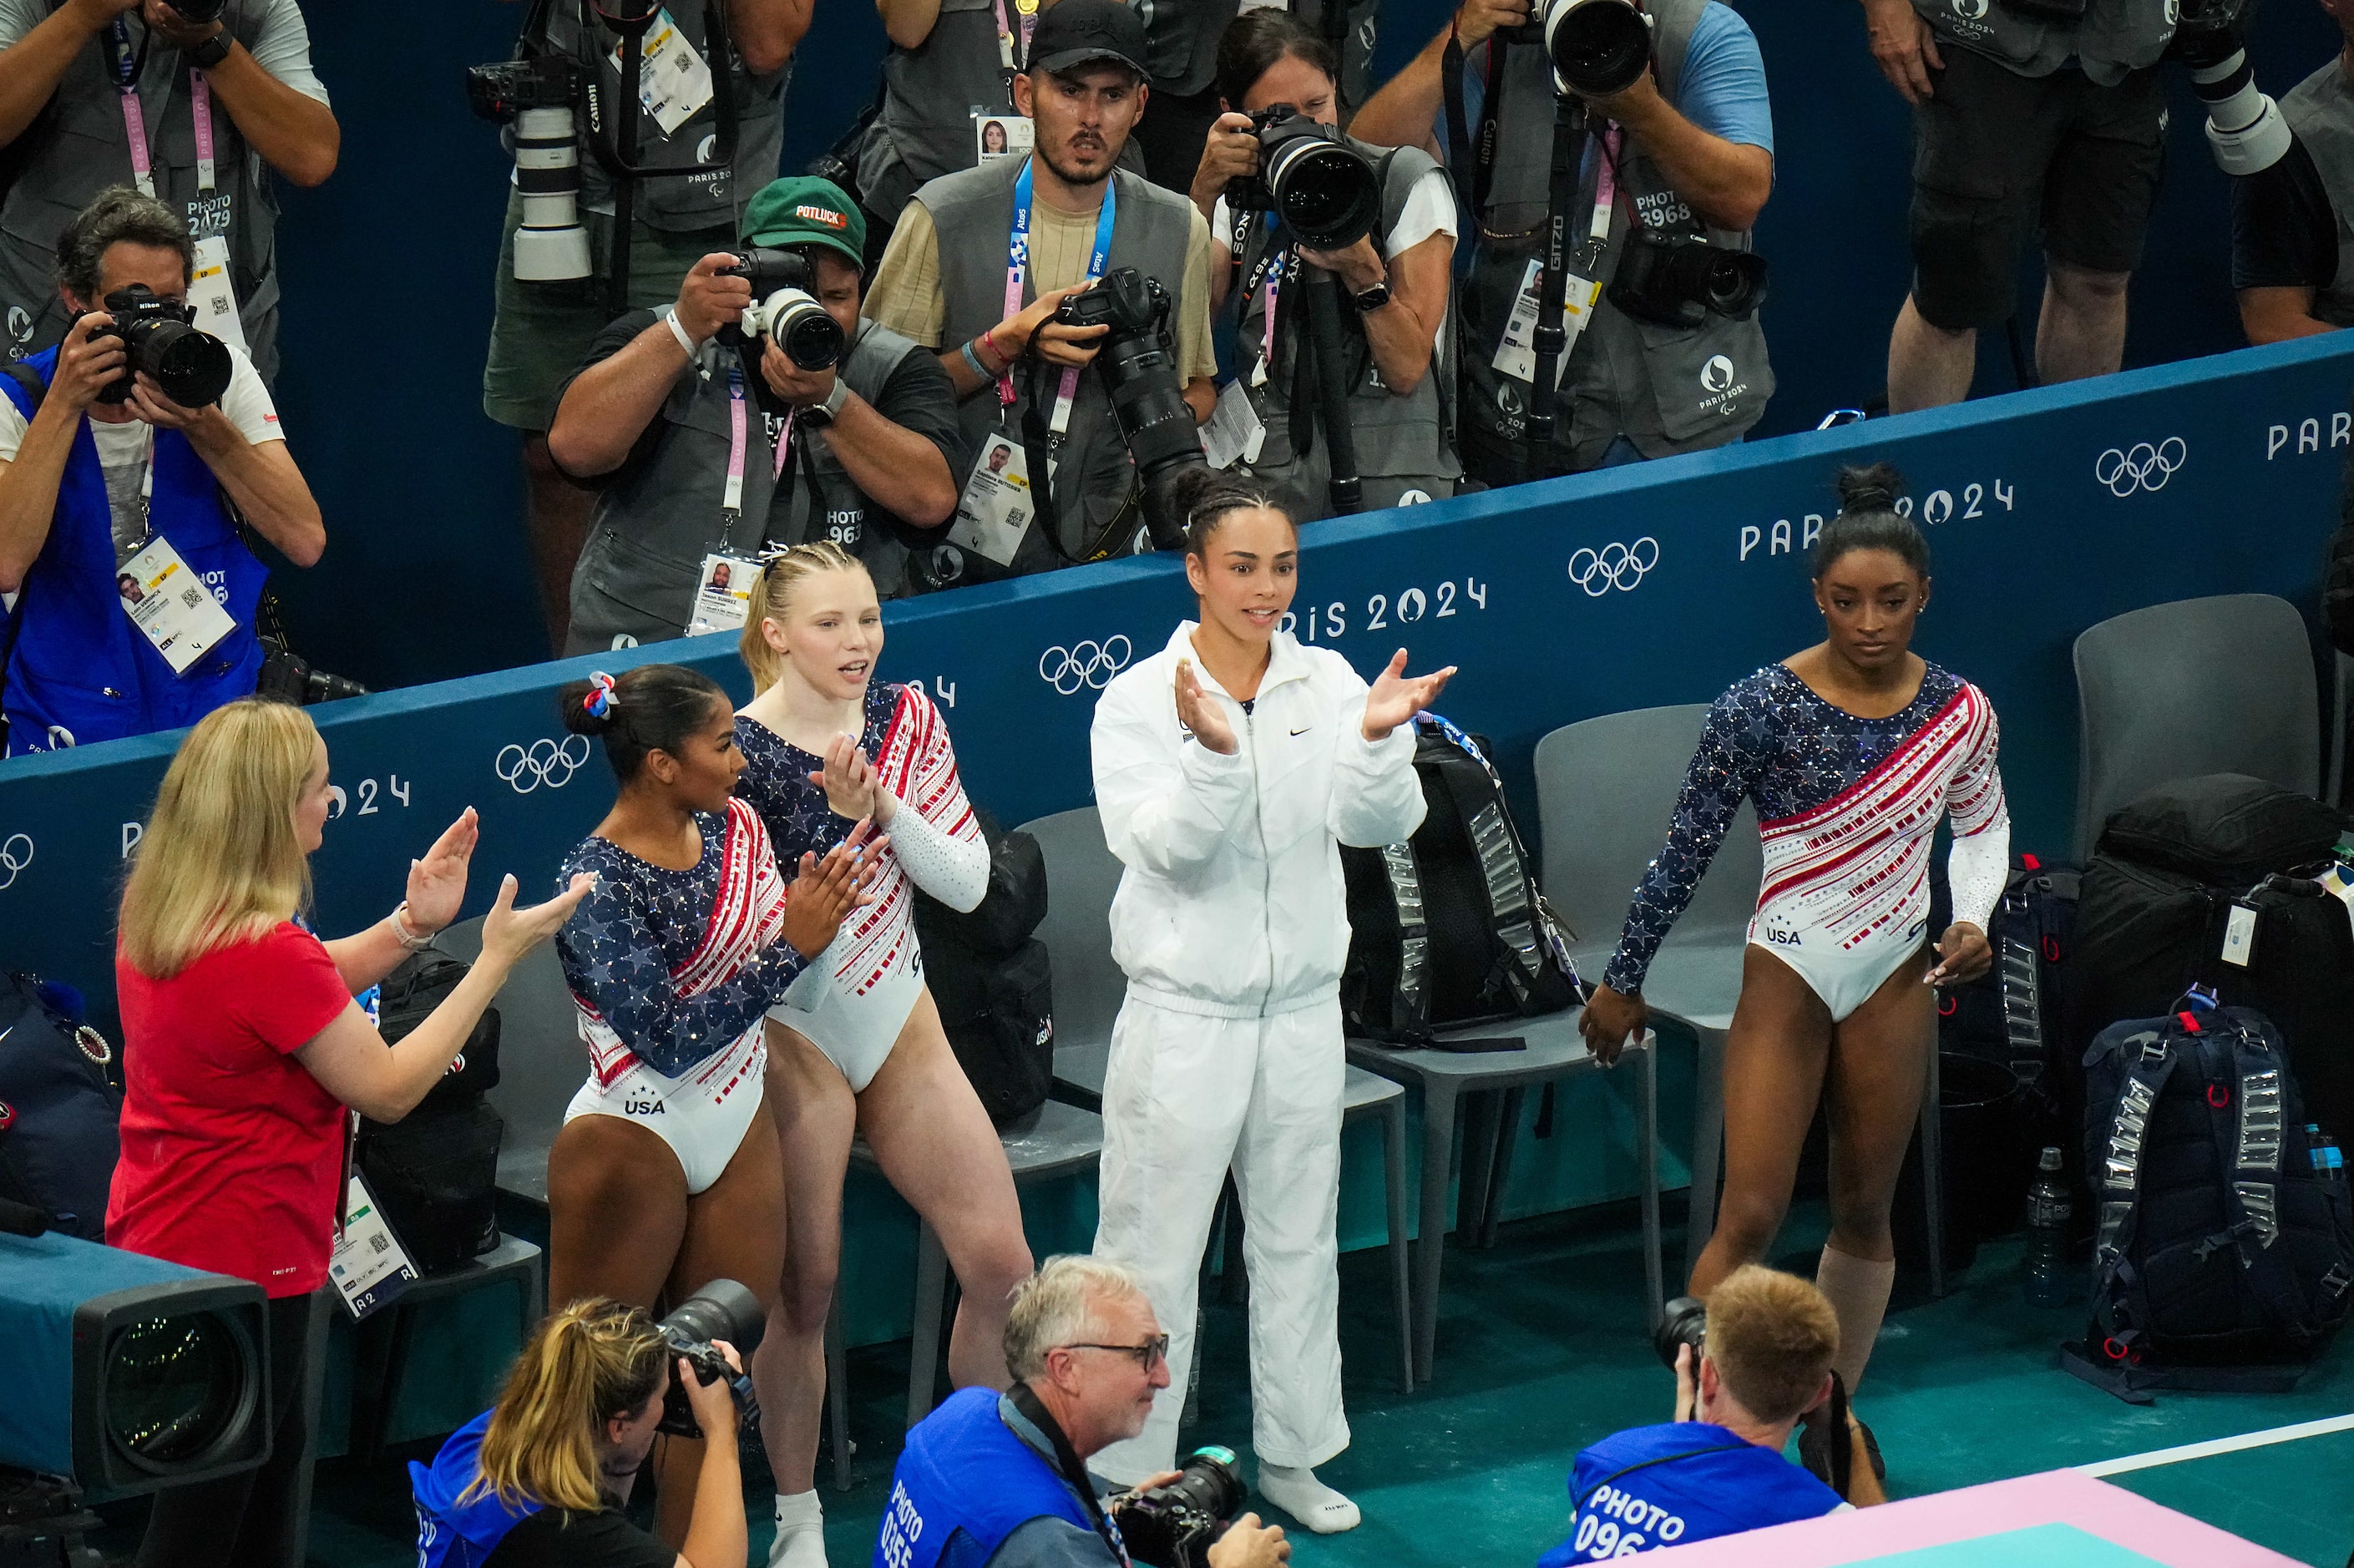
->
[106,699,589,1568]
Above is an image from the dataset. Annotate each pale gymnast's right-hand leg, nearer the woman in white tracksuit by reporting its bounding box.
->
[859,989,1031,1389]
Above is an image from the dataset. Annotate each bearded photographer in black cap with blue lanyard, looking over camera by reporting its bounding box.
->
[866,0,1217,574]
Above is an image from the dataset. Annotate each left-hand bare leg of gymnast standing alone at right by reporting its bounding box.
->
[1688,947,1831,1297]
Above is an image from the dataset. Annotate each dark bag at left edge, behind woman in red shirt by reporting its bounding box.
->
[0,974,123,1241]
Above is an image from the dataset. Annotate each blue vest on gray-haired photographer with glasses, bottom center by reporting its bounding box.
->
[873,1389,1095,1568]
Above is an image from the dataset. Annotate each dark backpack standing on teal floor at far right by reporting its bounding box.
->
[2062,996,2354,1404]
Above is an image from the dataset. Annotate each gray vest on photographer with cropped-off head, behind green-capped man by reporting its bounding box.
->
[549,0,793,231]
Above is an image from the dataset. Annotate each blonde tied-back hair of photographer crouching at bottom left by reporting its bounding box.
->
[459,1297,664,1514]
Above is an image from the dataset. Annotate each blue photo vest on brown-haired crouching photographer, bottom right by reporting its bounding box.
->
[1537,1422,1843,1568]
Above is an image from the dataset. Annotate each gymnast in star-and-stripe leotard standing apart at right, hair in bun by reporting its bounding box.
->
[1582,464,2010,1440]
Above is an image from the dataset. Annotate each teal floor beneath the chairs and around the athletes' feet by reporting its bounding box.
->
[119,1206,2354,1568]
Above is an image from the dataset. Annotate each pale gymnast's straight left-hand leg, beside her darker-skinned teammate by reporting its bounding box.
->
[753,1022,857,1497]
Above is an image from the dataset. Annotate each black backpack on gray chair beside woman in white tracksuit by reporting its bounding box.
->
[1339,713,1582,1045]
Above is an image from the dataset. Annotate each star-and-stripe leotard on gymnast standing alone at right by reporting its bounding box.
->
[1603,664,2010,1019]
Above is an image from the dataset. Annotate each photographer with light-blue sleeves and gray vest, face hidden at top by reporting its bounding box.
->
[1349,0,1773,485]
